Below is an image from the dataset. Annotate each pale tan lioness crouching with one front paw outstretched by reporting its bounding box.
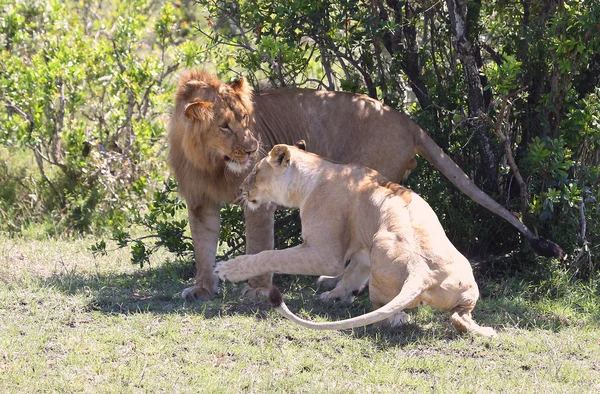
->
[215,145,495,336]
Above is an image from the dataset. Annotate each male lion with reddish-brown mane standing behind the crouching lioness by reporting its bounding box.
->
[169,71,563,299]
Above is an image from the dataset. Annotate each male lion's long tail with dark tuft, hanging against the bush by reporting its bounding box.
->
[415,125,565,259]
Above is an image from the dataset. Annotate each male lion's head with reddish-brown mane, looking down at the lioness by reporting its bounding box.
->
[170,71,259,173]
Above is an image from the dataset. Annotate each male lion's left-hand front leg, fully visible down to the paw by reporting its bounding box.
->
[181,201,221,300]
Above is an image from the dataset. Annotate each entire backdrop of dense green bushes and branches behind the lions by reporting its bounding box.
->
[0,0,600,278]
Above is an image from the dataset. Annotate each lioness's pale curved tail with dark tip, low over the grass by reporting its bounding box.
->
[269,279,423,330]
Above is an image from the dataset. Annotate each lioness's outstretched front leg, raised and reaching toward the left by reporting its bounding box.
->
[215,244,344,282]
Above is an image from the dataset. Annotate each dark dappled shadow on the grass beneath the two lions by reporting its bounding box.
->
[39,261,600,345]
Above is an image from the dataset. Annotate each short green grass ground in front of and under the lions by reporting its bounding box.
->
[0,237,600,393]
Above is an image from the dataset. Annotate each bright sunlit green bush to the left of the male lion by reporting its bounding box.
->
[0,0,201,235]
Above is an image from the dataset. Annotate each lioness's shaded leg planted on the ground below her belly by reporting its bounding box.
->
[320,249,371,302]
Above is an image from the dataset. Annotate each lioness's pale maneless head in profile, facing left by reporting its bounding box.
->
[241,141,306,209]
